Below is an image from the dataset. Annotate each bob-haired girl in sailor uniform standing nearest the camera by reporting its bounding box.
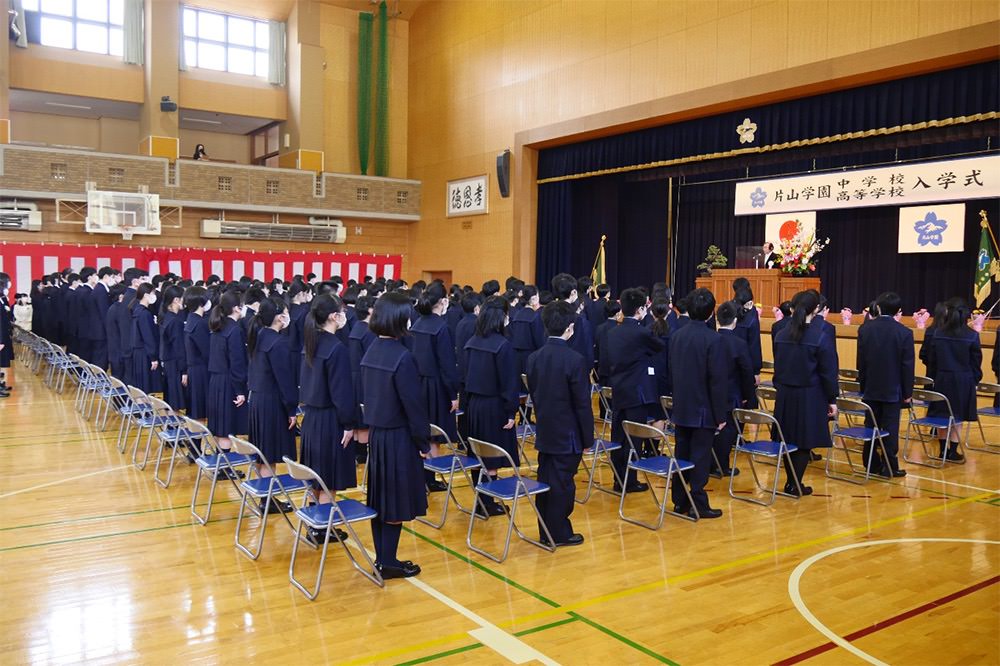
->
[361,292,430,578]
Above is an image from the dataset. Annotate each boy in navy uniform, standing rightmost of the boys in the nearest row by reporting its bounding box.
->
[858,291,914,477]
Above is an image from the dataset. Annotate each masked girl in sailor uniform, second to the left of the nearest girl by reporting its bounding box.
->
[247,296,299,510]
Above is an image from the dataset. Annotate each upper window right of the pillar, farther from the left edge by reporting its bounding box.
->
[183,5,271,77]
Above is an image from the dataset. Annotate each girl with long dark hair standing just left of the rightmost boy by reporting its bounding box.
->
[774,291,840,495]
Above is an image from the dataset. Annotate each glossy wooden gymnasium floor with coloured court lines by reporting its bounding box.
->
[0,356,1000,665]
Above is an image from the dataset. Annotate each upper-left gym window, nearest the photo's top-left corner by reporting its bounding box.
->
[23,0,125,56]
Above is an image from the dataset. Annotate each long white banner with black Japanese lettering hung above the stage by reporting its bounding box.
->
[735,155,1000,215]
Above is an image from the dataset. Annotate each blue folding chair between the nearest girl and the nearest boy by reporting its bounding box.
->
[465,437,556,563]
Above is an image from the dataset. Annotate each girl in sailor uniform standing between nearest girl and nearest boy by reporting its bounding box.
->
[462,296,521,515]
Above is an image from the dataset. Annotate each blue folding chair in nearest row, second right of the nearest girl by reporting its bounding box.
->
[618,421,700,530]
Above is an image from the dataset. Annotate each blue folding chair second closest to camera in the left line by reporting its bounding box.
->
[229,437,309,560]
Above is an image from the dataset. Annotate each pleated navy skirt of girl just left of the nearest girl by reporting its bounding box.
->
[302,406,358,490]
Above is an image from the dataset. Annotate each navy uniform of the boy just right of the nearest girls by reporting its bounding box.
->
[527,337,594,543]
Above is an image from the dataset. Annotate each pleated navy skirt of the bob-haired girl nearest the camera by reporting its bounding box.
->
[367,427,427,522]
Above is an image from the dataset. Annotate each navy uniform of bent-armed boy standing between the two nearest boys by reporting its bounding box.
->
[600,317,663,479]
